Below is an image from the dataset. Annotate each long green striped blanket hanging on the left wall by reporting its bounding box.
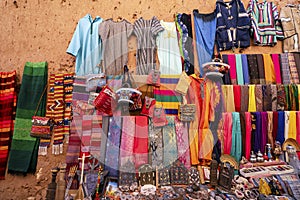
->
[8,62,48,173]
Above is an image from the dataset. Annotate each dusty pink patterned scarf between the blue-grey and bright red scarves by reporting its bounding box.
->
[120,116,135,166]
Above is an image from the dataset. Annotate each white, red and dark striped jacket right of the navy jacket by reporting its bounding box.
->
[247,0,283,46]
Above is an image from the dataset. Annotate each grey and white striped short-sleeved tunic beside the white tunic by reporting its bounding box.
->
[134,16,164,75]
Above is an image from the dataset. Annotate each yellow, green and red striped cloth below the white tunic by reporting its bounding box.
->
[153,75,182,115]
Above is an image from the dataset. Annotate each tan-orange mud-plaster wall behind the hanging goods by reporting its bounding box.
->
[0,0,287,200]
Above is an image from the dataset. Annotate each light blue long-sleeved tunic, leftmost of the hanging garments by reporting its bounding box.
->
[67,14,102,76]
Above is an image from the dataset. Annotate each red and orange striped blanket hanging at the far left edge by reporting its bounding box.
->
[0,71,17,180]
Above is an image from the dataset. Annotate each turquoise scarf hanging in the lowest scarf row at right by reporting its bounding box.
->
[230,112,242,162]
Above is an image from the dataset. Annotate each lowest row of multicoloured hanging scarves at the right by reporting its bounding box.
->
[219,111,300,162]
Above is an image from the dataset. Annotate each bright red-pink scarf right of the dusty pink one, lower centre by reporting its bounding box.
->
[133,116,148,169]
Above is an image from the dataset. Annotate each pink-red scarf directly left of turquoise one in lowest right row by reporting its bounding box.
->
[223,112,232,155]
